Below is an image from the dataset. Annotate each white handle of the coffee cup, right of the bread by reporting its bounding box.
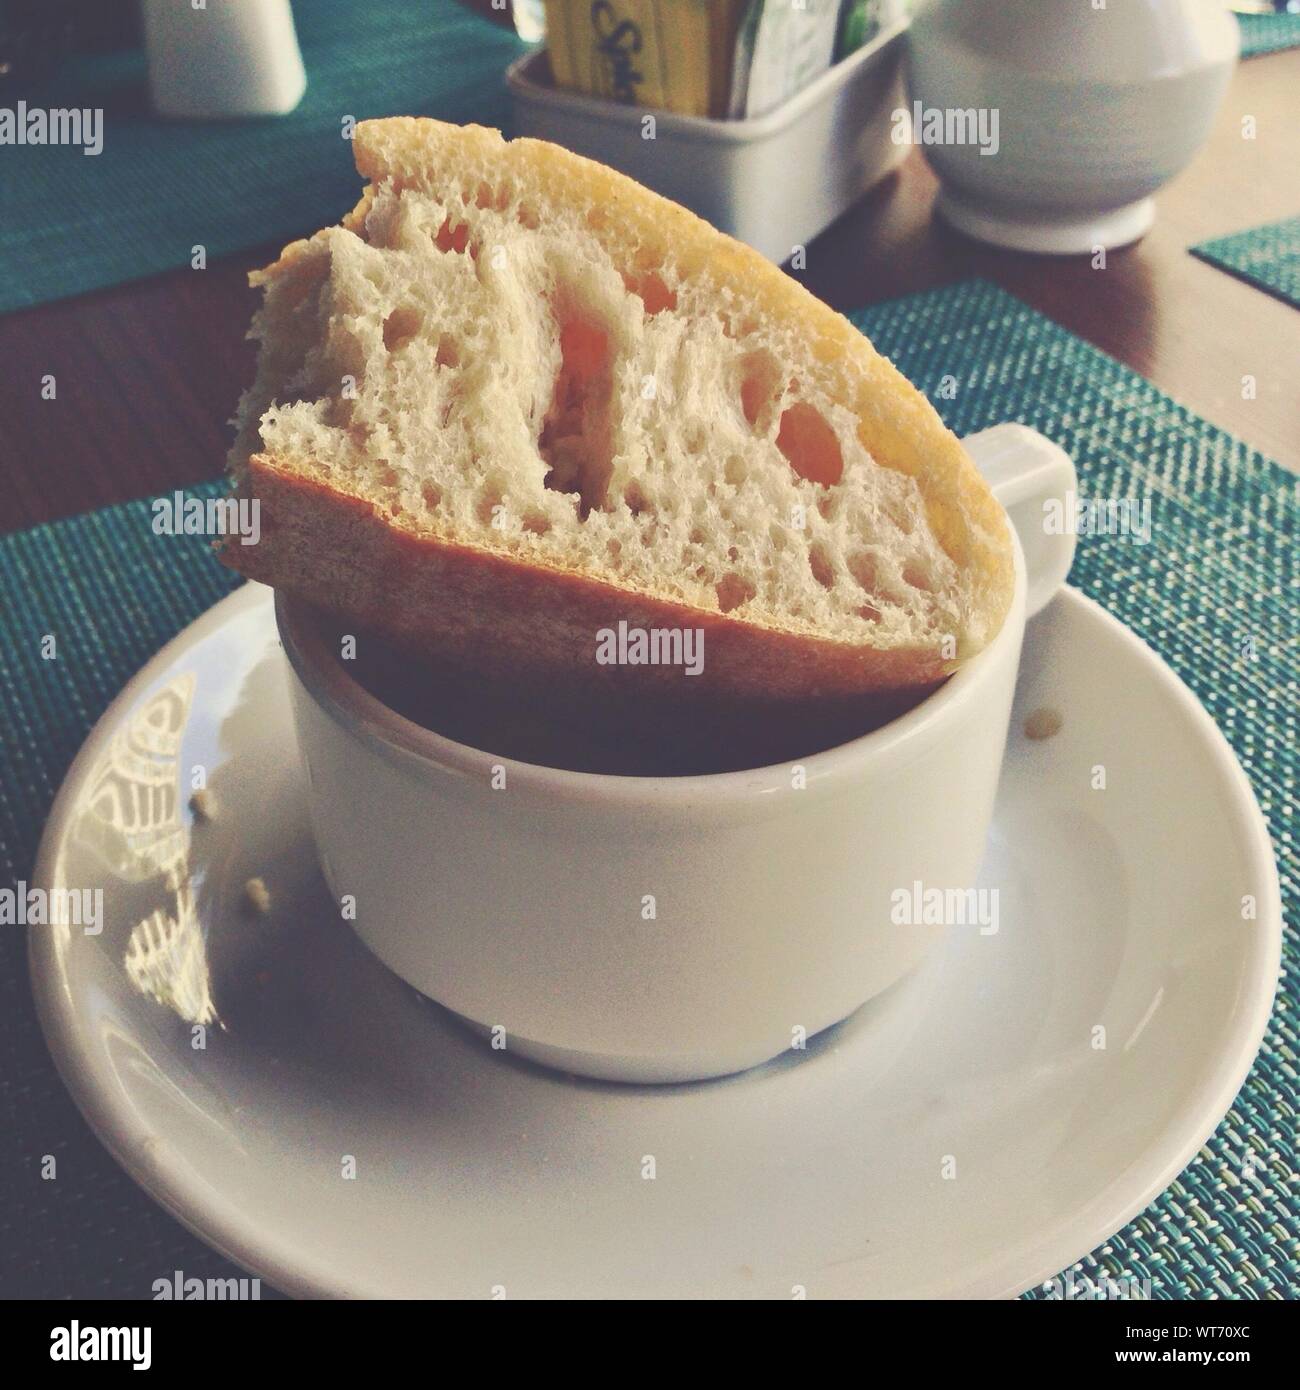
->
[962,424,1079,617]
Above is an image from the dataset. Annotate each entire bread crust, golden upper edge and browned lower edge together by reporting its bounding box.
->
[220,117,1014,702]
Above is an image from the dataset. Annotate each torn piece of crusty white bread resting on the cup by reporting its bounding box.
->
[222,118,1014,701]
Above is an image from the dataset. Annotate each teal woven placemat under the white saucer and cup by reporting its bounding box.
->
[0,281,1300,1298]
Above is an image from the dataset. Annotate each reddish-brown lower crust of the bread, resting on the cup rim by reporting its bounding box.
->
[220,455,957,703]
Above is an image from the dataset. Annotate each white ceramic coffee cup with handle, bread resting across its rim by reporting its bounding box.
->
[275,425,1075,1081]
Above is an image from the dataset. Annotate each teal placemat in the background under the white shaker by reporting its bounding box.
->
[0,0,524,311]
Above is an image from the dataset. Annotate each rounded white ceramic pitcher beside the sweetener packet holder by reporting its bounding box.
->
[909,0,1240,254]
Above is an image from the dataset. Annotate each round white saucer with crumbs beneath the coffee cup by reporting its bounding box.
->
[31,585,1281,1298]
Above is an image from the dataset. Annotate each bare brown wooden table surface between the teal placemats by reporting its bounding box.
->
[0,32,1300,542]
